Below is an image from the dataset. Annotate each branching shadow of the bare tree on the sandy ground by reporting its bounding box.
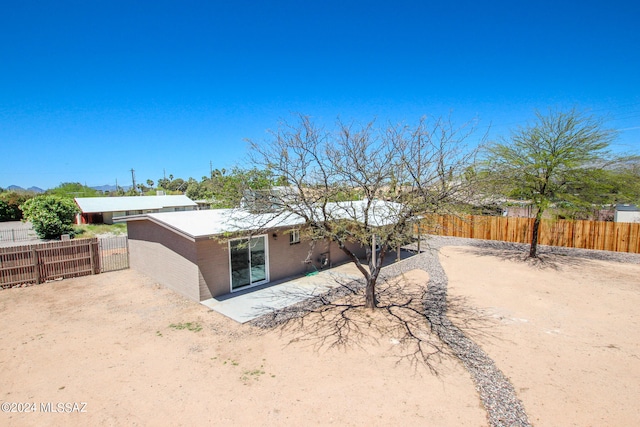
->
[251,273,494,375]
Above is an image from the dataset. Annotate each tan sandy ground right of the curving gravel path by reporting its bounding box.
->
[440,247,640,426]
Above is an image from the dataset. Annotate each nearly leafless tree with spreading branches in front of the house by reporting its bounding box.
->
[250,115,477,308]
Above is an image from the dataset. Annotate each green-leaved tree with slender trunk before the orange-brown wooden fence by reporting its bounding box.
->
[486,110,615,258]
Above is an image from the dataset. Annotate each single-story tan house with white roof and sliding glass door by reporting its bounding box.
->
[125,202,402,301]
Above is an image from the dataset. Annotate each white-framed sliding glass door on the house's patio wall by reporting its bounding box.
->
[229,236,269,291]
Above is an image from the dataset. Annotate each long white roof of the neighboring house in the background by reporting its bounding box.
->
[75,195,198,213]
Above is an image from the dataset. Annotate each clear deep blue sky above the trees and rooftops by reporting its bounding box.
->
[0,0,640,189]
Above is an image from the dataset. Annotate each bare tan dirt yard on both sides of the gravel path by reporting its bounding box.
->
[0,248,640,426]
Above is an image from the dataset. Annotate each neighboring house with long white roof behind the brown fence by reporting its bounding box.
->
[74,195,197,224]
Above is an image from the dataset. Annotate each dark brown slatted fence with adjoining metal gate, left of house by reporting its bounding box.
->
[0,236,129,288]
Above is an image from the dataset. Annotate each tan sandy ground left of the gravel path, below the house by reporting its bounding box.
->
[0,270,486,426]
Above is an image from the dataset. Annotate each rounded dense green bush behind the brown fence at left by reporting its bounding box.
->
[21,195,80,239]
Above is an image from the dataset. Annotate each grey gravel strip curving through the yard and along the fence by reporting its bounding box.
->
[250,236,640,427]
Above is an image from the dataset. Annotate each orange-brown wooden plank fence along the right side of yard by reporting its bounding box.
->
[416,215,640,253]
